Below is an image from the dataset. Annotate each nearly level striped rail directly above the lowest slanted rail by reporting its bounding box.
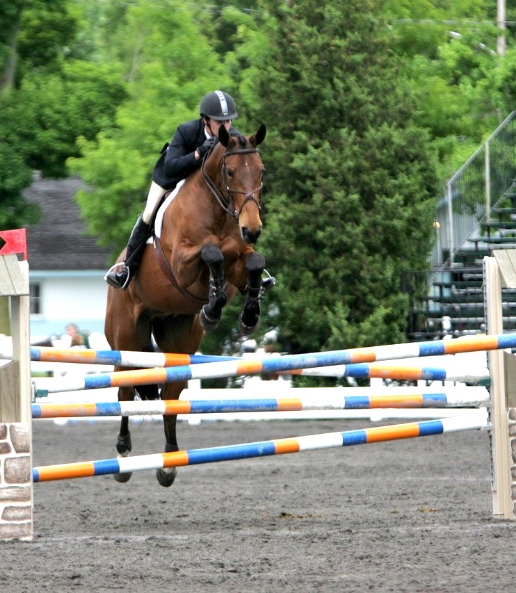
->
[32,393,489,418]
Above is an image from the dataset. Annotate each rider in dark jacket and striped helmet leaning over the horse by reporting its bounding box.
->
[104,91,239,290]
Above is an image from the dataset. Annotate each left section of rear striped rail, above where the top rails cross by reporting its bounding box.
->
[0,346,235,368]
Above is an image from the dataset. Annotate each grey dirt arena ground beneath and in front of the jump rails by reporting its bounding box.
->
[0,420,516,593]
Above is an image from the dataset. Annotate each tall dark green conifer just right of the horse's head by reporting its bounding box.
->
[257,0,437,352]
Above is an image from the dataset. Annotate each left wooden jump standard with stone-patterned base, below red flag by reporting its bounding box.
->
[0,231,33,540]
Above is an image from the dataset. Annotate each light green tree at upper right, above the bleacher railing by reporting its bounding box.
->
[382,0,512,184]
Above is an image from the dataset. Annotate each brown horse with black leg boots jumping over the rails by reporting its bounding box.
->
[104,124,267,487]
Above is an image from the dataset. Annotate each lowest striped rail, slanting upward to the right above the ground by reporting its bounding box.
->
[32,417,487,482]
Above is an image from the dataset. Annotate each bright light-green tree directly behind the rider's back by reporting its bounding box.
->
[69,2,236,257]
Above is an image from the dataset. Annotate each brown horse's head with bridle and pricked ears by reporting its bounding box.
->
[203,124,266,243]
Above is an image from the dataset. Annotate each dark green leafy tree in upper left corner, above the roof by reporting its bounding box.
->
[0,0,120,228]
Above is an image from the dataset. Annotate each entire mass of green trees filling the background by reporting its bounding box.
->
[0,0,516,353]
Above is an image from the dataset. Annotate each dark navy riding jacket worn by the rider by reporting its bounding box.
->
[152,118,240,190]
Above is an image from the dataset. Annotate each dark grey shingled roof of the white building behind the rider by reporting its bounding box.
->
[24,175,110,271]
